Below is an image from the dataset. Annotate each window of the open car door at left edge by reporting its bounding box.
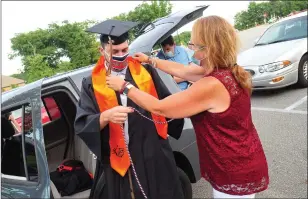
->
[1,105,38,181]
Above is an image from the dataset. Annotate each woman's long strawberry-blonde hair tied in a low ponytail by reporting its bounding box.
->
[192,16,252,93]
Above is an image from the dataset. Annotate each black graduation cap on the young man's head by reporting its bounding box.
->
[86,19,139,45]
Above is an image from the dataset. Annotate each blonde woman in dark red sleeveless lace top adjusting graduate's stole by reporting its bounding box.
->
[107,16,269,198]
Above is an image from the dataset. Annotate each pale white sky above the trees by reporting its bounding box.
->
[1,1,249,75]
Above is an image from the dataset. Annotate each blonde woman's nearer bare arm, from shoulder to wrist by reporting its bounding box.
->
[128,77,220,118]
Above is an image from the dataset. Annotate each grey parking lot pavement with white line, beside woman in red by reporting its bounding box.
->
[193,86,307,198]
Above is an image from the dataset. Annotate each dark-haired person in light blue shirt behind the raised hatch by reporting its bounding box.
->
[157,35,192,90]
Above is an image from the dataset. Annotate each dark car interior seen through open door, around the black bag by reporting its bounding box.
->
[42,89,96,198]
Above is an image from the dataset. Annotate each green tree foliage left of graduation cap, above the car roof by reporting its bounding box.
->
[9,21,99,82]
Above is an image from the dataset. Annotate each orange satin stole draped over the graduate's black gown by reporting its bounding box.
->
[92,56,168,177]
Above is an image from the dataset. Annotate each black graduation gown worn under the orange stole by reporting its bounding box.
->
[75,65,184,199]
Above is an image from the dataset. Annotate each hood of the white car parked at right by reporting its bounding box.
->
[237,38,307,67]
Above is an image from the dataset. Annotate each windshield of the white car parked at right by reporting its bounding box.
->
[256,16,307,45]
